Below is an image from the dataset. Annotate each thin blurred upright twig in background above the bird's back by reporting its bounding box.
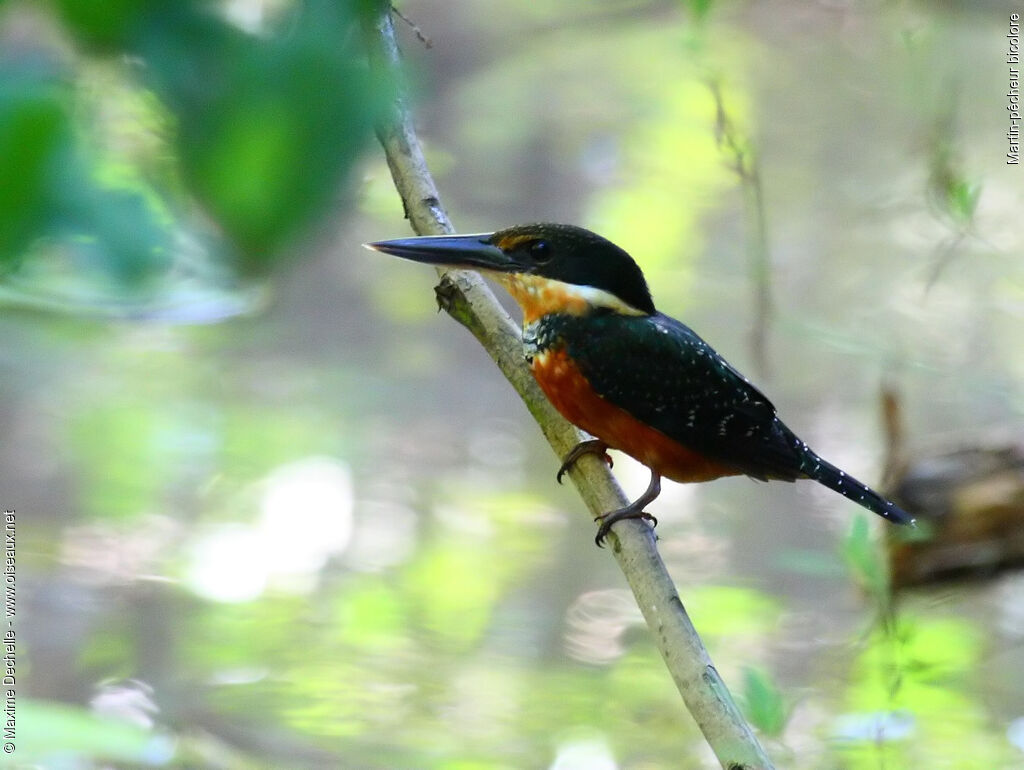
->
[707,78,773,376]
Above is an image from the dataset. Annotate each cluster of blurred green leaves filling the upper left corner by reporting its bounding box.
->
[0,0,386,313]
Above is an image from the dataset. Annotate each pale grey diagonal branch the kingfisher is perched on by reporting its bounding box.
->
[366,6,773,770]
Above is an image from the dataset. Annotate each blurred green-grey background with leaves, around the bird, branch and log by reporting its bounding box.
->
[0,0,1024,770]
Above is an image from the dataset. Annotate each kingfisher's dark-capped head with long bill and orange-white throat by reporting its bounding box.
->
[367,224,654,323]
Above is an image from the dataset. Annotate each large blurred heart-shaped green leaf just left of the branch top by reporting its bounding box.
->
[133,0,380,270]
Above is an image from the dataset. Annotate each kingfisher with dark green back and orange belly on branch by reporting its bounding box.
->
[365,223,913,546]
